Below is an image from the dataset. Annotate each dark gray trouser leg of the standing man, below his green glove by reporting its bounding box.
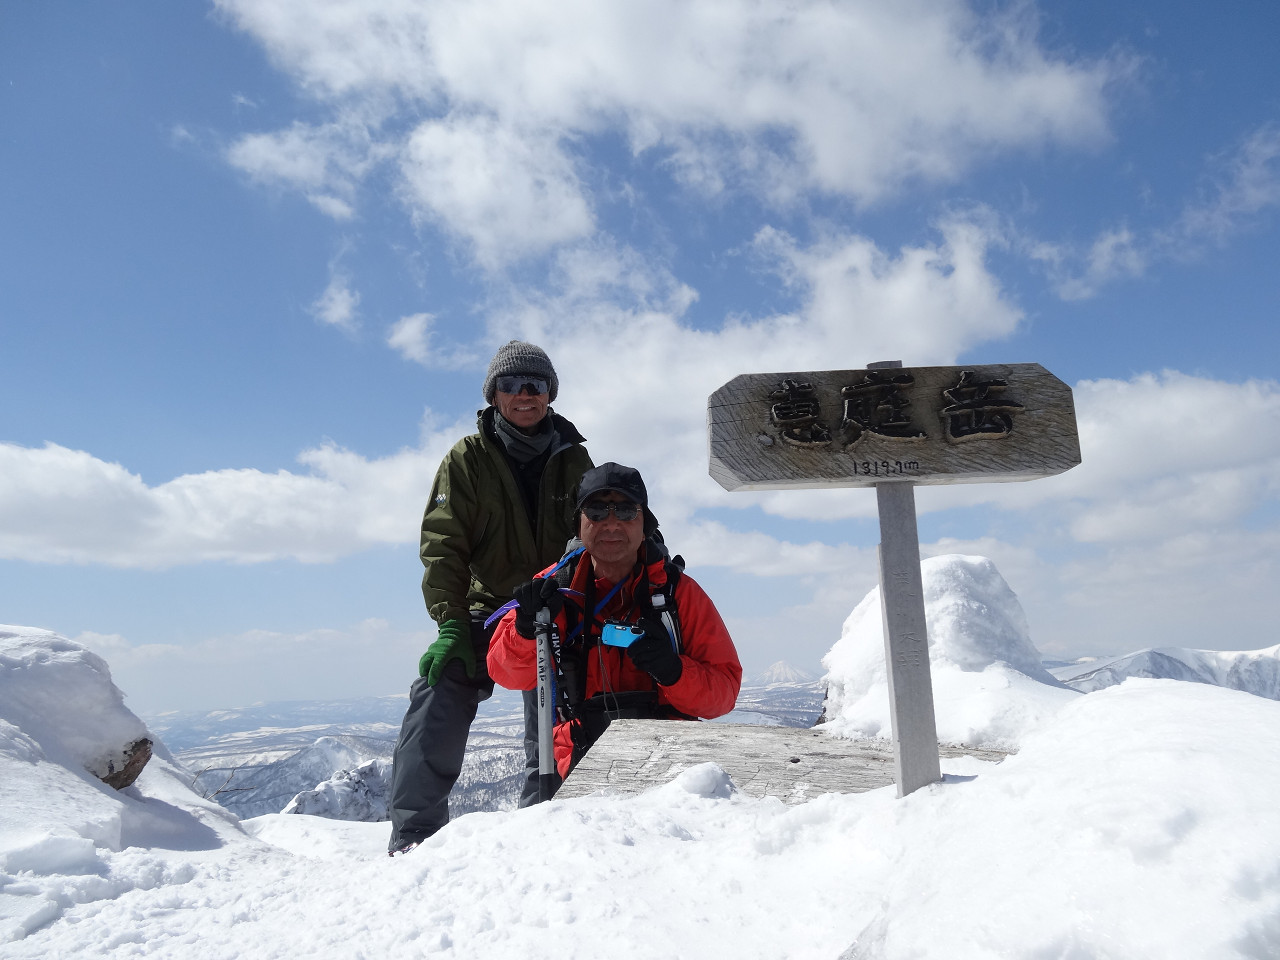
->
[388,620,494,850]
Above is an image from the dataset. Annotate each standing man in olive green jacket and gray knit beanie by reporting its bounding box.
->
[388,340,591,855]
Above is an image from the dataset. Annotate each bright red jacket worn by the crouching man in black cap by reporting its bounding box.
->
[489,548,742,777]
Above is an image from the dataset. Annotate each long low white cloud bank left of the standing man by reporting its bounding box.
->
[0,421,474,568]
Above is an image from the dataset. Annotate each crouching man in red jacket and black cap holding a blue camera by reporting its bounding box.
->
[488,463,742,786]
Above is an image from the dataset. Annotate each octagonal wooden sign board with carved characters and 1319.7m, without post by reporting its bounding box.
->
[707,364,1080,490]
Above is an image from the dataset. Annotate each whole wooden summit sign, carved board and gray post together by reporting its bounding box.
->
[707,361,1080,796]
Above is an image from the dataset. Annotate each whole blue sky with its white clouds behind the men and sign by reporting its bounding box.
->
[0,0,1280,710]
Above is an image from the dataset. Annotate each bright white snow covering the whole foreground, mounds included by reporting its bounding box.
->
[0,558,1280,960]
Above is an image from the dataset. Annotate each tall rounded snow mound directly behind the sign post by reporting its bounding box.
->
[823,556,1079,750]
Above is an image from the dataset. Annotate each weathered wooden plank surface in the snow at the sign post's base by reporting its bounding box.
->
[556,721,1006,804]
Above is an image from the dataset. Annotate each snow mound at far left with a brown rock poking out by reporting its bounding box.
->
[0,626,247,956]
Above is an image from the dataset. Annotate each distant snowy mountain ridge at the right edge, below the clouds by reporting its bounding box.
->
[1050,645,1280,700]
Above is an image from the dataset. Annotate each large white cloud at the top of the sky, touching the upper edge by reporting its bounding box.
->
[218,0,1132,265]
